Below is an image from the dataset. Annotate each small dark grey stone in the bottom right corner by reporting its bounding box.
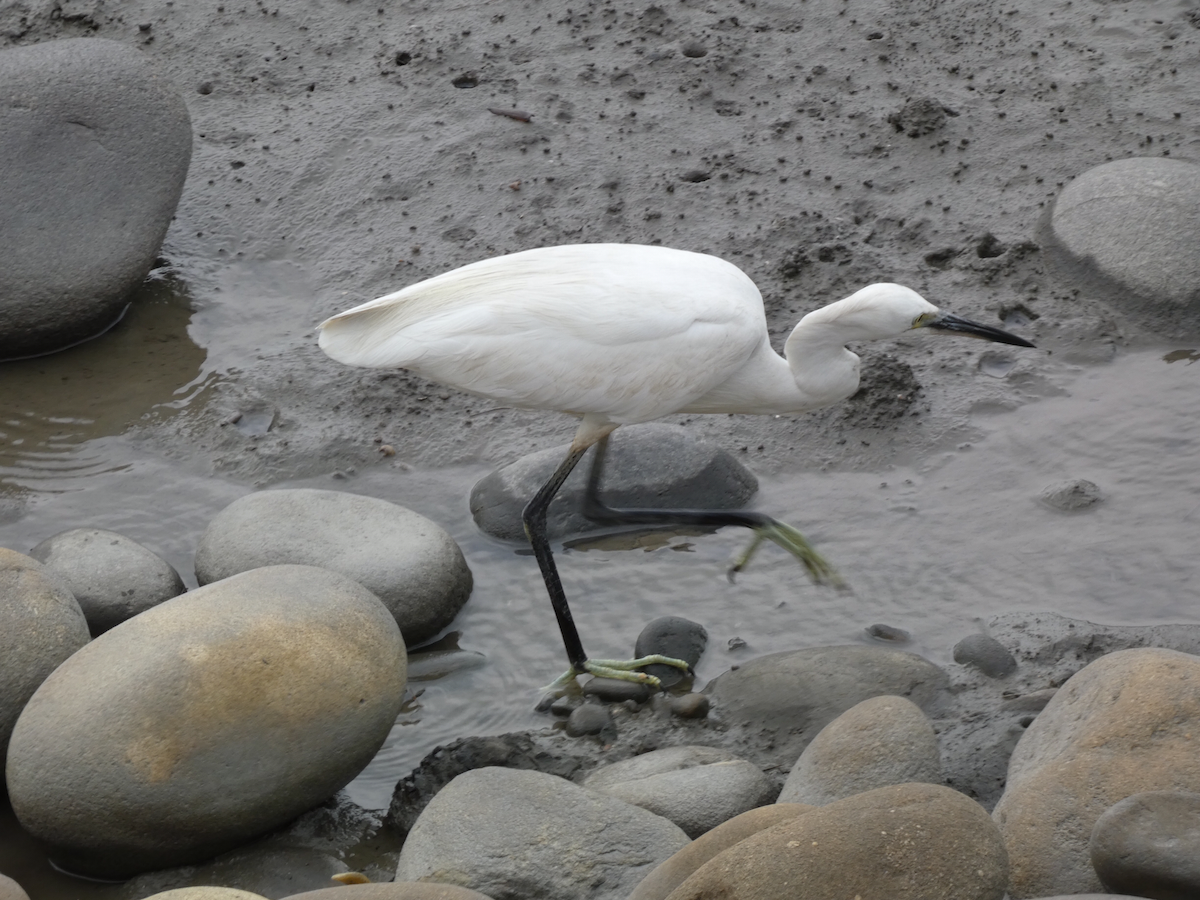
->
[1088,791,1200,900]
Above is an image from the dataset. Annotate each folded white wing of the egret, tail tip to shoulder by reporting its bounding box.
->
[320,244,766,424]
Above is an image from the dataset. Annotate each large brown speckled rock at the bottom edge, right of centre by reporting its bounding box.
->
[668,785,1008,900]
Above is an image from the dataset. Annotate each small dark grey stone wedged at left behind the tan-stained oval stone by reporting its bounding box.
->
[29,528,185,635]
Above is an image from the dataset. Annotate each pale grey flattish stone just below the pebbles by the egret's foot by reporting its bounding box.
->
[583,746,776,839]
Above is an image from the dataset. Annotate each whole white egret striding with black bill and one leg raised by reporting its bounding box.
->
[319,244,1033,688]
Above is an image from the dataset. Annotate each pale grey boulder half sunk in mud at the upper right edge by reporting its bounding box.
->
[1039,157,1200,337]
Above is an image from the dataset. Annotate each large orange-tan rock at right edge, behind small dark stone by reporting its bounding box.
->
[994,648,1200,898]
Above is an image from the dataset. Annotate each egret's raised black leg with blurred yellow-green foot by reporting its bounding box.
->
[583,437,845,587]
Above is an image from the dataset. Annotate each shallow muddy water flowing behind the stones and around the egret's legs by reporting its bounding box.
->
[0,285,1200,895]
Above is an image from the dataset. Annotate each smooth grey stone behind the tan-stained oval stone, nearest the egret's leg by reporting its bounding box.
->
[196,488,472,646]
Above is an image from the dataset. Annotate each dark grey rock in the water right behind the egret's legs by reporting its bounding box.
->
[470,422,758,541]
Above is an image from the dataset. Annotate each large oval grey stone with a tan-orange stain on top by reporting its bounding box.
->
[7,565,404,878]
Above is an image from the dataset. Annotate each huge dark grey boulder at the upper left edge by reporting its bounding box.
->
[0,37,192,359]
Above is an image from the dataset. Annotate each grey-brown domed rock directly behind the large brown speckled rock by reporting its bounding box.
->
[778,696,942,806]
